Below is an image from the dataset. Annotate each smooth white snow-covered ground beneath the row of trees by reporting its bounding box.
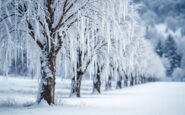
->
[0,77,185,115]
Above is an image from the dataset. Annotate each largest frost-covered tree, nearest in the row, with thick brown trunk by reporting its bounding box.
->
[1,0,92,104]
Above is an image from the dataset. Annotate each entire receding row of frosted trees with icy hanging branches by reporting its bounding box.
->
[0,0,164,104]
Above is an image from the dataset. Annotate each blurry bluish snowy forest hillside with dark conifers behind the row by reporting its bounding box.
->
[133,0,185,81]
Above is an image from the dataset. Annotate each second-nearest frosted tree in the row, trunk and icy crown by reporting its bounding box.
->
[70,13,106,97]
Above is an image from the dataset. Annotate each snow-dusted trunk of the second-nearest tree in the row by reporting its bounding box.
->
[70,71,83,97]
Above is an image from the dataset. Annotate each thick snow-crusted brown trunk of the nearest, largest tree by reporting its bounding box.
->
[37,51,56,105]
